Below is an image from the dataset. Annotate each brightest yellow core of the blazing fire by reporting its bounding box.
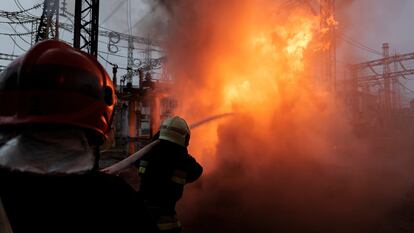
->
[220,14,314,111]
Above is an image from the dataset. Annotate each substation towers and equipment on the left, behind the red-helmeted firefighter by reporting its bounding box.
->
[0,0,176,157]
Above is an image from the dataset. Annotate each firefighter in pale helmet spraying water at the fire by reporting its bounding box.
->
[136,116,203,232]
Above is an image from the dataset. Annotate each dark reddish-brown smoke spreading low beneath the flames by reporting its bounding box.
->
[182,116,413,232]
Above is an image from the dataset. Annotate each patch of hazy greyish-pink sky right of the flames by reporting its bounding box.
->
[337,0,414,104]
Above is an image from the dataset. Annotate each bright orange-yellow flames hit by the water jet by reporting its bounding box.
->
[168,1,320,167]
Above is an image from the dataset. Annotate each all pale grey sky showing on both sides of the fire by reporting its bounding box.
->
[0,0,414,99]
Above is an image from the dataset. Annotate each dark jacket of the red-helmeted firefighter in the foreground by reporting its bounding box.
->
[0,168,157,233]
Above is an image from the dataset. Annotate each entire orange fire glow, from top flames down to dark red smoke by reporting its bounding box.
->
[160,0,411,233]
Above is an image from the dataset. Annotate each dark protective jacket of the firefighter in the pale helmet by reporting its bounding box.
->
[136,140,203,215]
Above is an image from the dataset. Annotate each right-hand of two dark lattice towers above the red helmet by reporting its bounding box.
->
[73,0,99,57]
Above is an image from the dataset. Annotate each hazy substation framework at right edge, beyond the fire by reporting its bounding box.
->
[345,43,414,133]
